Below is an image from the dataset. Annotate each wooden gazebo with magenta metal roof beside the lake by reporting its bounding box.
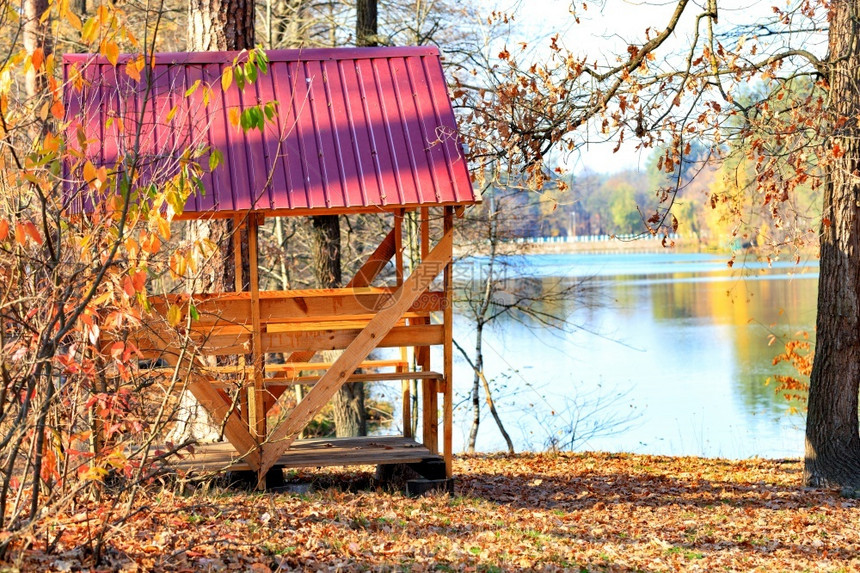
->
[64,47,475,483]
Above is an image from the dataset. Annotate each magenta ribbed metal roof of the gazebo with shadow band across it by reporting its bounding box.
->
[63,47,475,216]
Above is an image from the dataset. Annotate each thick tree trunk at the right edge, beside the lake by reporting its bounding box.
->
[804,0,860,488]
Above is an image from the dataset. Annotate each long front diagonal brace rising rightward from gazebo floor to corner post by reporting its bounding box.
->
[259,230,453,479]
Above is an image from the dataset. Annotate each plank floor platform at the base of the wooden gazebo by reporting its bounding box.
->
[172,436,442,472]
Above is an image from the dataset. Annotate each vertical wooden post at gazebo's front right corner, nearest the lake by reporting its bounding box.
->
[444,207,454,478]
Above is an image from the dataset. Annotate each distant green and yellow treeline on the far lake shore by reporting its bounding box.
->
[483,144,821,249]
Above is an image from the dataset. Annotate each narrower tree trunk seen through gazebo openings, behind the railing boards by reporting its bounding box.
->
[311,215,367,437]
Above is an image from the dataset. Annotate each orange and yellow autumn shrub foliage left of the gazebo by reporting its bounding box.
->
[0,2,274,555]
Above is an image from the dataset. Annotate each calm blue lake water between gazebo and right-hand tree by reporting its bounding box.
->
[444,254,818,458]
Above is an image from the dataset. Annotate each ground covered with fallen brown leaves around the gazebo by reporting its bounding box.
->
[0,453,860,573]
